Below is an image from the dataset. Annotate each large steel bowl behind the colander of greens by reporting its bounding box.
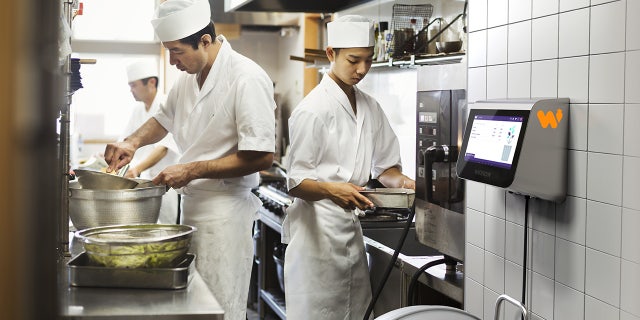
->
[69,179,166,230]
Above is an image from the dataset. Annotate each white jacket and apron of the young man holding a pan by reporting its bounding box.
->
[282,75,401,320]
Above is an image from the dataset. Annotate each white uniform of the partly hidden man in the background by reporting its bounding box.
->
[120,93,179,224]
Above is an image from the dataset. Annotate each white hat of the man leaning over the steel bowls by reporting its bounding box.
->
[151,0,211,42]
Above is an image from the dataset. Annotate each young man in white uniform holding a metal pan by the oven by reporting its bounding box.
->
[282,15,415,320]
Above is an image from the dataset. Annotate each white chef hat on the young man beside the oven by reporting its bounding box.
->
[327,15,375,48]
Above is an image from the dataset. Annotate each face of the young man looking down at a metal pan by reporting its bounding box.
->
[329,47,373,86]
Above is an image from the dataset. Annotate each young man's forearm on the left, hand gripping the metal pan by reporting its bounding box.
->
[289,179,373,210]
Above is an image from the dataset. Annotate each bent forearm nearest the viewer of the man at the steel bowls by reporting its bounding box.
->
[153,151,273,189]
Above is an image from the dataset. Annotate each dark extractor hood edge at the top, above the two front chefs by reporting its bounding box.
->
[222,0,372,13]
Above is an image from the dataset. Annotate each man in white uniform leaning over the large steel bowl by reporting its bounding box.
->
[105,0,275,320]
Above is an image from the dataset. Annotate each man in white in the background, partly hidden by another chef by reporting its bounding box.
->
[120,60,179,224]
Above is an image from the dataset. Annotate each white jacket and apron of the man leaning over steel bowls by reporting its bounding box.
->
[154,35,275,320]
